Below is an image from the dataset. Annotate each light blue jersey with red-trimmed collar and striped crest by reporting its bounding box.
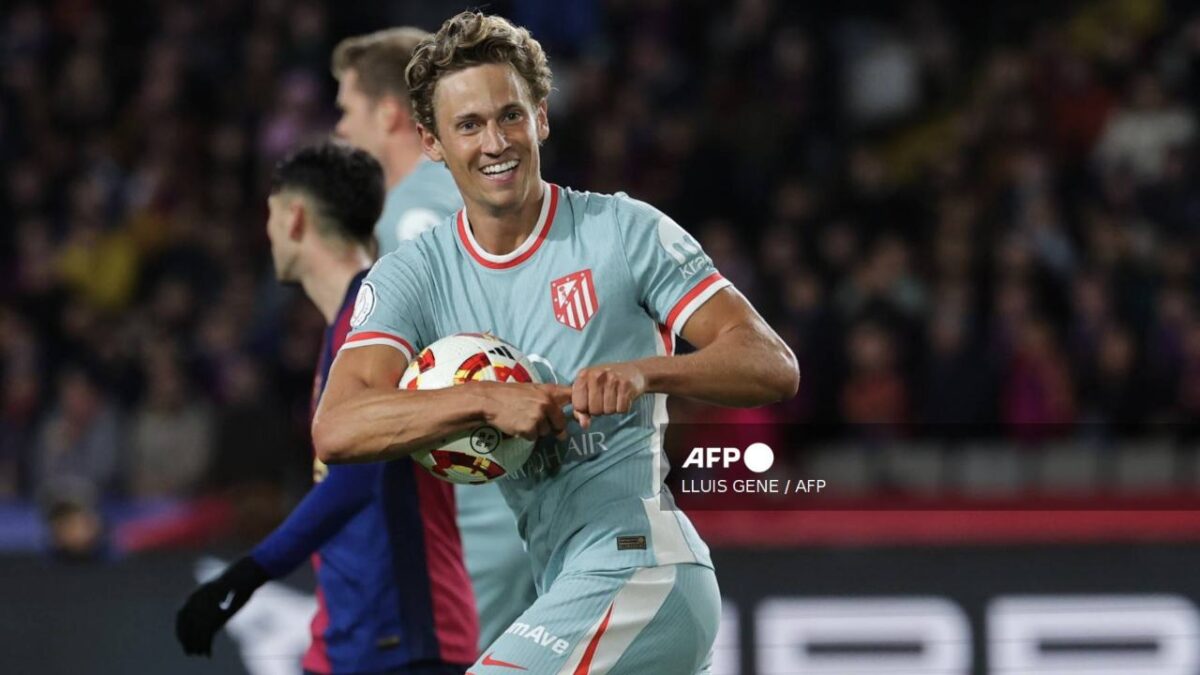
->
[343,185,728,591]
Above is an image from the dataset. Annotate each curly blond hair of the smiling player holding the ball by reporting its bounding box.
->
[404,12,551,133]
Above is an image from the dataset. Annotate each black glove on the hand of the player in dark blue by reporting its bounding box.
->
[175,556,270,656]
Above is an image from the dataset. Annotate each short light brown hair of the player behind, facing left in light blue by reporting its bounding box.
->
[331,26,431,101]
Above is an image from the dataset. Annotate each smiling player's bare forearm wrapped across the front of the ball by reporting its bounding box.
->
[312,387,484,464]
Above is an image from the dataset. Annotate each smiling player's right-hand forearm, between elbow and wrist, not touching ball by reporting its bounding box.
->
[636,325,800,407]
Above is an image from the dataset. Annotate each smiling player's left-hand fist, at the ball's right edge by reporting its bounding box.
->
[469,382,571,441]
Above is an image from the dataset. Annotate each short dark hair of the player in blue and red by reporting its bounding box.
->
[271,142,385,244]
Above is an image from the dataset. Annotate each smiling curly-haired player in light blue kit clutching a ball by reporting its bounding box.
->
[313,12,799,675]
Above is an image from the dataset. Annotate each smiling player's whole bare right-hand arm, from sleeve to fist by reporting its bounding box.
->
[571,287,800,424]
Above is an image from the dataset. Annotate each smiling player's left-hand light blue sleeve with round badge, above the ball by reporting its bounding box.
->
[342,243,430,360]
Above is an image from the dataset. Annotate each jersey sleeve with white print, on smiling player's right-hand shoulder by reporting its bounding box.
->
[616,196,730,335]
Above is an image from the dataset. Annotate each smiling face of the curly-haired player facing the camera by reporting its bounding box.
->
[421,64,550,214]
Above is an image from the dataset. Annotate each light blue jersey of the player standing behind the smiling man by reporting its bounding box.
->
[376,159,538,649]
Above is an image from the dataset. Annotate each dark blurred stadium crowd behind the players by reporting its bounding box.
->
[0,0,1200,526]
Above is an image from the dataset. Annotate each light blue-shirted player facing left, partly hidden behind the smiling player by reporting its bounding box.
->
[332,28,538,649]
